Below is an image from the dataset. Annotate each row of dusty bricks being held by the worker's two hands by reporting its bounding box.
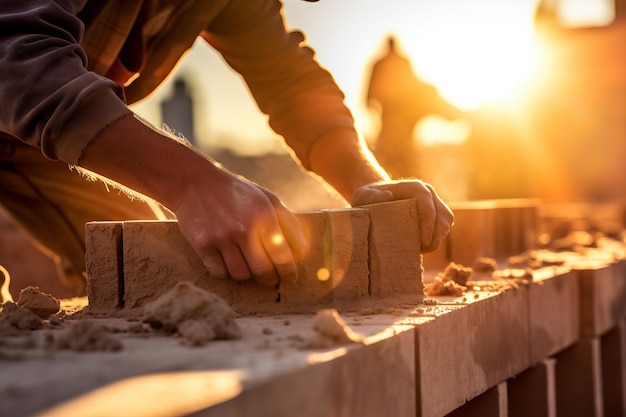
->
[86,200,424,313]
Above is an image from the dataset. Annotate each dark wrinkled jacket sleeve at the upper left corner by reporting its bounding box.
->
[0,0,130,163]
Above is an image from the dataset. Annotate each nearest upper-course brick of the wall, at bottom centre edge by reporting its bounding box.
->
[202,330,416,417]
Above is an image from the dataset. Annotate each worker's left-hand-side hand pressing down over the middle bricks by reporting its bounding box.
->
[175,172,308,285]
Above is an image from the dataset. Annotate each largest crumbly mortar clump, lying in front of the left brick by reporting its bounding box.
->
[143,281,241,346]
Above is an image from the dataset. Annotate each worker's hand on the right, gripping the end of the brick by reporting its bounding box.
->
[350,180,454,252]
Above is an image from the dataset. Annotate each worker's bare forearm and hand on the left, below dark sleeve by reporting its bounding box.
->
[79,115,307,285]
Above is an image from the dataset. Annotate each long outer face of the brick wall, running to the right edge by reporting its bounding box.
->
[203,261,626,417]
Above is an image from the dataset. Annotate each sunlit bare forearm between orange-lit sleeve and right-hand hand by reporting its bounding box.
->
[308,128,390,201]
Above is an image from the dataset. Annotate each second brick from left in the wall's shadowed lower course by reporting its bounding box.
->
[507,359,556,417]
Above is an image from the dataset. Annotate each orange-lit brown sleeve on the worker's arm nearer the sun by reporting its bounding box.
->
[203,0,354,168]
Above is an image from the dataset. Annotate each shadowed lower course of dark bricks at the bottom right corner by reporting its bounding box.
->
[447,319,626,417]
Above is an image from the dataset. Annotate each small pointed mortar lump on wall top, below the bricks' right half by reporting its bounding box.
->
[307,308,364,349]
